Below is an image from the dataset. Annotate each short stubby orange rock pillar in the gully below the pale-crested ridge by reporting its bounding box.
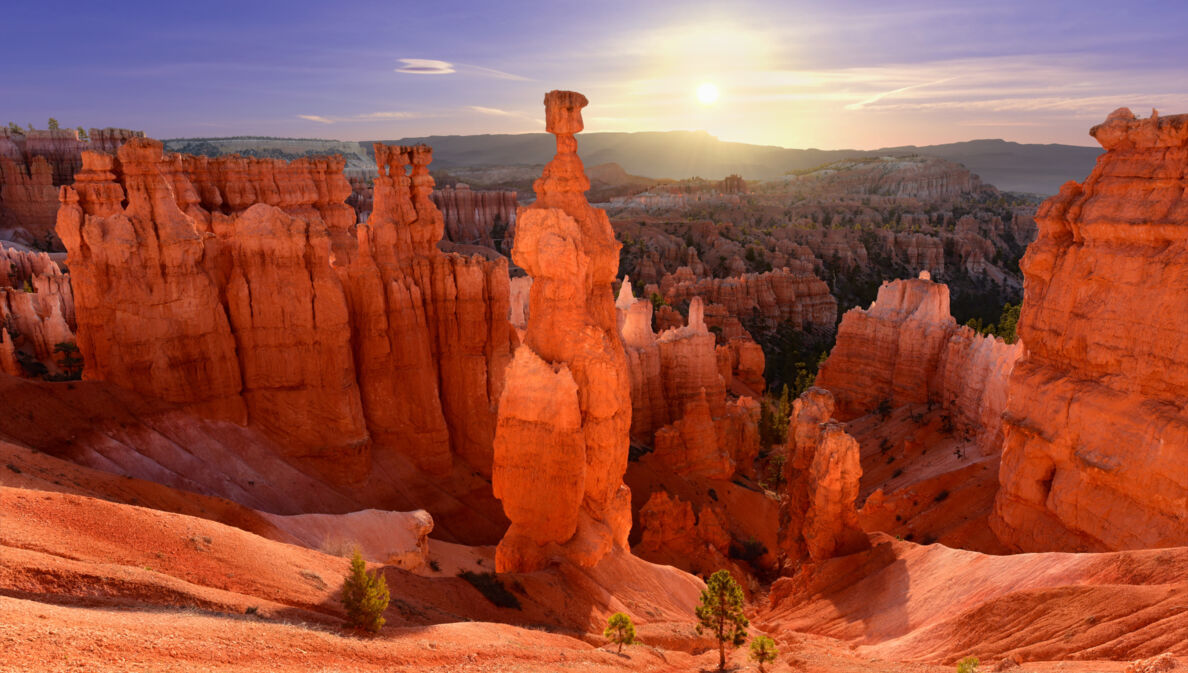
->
[779,388,870,561]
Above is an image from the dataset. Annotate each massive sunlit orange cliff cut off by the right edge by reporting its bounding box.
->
[991,109,1188,551]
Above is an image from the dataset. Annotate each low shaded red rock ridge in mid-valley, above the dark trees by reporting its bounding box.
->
[661,264,838,329]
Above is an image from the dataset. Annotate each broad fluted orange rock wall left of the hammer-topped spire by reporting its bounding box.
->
[57,138,510,482]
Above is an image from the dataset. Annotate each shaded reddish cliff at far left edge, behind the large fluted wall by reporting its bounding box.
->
[0,128,144,250]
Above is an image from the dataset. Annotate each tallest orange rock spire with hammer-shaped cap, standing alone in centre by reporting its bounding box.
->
[493,90,631,572]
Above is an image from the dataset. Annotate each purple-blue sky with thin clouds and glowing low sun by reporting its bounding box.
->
[0,0,1188,147]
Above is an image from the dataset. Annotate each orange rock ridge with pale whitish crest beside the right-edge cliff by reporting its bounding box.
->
[816,272,1023,446]
